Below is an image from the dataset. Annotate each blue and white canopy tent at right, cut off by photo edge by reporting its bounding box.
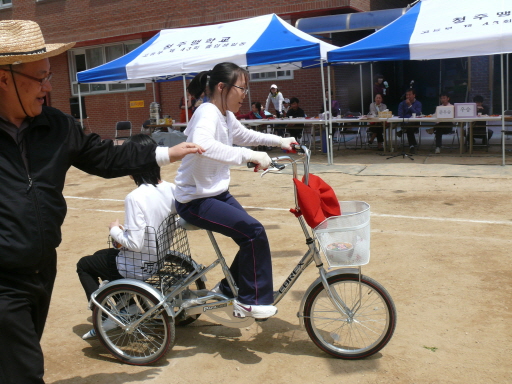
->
[327,0,512,165]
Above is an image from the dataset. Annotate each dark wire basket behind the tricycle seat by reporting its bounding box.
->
[109,214,194,292]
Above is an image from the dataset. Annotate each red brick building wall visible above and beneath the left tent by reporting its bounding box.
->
[0,0,428,138]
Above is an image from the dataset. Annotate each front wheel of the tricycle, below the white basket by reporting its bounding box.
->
[304,274,396,359]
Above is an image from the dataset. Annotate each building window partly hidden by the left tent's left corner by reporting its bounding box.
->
[68,41,146,96]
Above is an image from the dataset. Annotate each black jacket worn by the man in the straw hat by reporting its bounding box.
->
[0,107,157,273]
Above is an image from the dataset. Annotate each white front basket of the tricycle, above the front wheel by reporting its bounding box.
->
[313,201,370,267]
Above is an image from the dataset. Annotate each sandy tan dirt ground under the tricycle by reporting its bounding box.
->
[42,151,512,384]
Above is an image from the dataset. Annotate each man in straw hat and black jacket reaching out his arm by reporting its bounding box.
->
[0,20,203,384]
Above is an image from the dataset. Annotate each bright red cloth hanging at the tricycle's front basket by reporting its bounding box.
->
[293,174,341,228]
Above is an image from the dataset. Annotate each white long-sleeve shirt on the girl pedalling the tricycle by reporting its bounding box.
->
[175,103,281,203]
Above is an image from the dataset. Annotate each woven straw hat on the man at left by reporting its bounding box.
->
[0,20,75,65]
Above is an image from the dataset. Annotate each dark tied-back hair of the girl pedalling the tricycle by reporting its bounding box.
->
[187,62,249,103]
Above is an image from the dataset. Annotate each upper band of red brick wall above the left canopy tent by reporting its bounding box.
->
[0,0,407,42]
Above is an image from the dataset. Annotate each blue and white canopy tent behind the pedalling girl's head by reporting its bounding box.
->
[77,14,338,160]
